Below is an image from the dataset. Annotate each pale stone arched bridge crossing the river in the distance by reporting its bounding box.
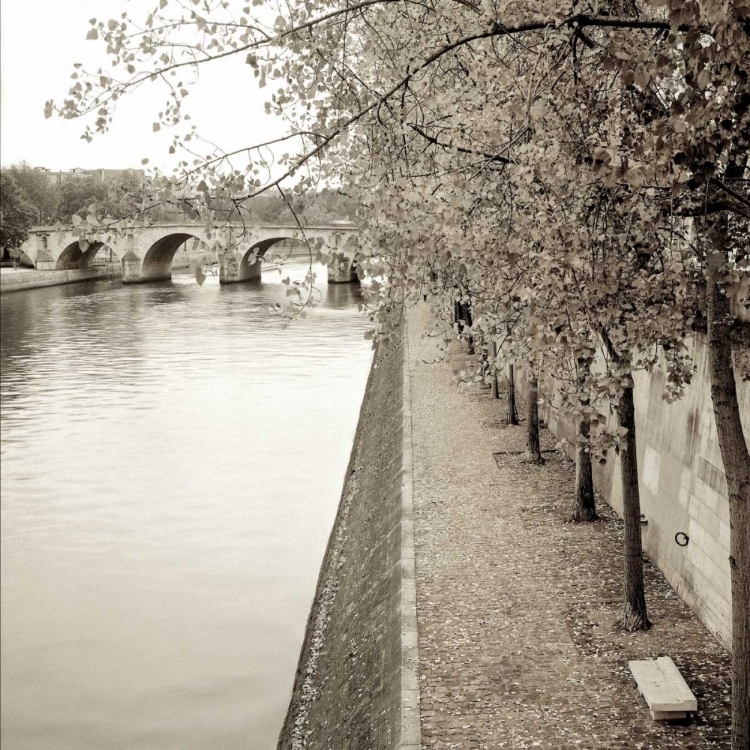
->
[21,222,358,284]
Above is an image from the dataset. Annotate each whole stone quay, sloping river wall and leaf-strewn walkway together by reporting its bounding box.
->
[278,304,730,750]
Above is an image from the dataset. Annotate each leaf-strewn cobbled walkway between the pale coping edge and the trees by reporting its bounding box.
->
[407,304,729,750]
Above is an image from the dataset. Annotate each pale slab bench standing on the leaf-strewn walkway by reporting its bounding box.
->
[628,656,698,721]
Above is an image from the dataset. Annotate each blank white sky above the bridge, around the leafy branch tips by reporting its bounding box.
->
[0,0,285,170]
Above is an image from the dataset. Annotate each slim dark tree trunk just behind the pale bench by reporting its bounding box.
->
[617,386,651,631]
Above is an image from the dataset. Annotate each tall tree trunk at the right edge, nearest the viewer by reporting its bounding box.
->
[707,272,750,750]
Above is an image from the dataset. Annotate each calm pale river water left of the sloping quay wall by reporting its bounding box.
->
[0,264,372,750]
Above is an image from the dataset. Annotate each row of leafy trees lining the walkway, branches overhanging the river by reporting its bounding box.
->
[46,0,750,750]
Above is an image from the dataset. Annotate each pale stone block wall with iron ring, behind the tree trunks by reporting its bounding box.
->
[545,337,750,646]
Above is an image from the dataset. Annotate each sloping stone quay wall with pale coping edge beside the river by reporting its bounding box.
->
[278,333,421,750]
